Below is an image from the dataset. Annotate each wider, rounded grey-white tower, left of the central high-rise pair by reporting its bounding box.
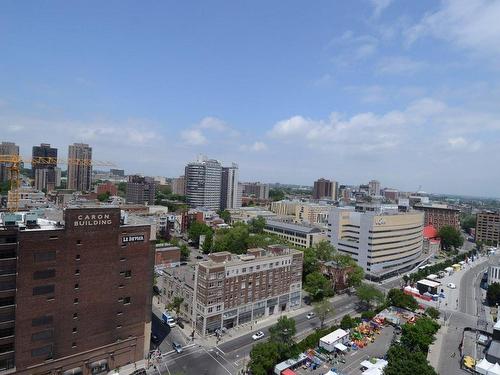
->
[184,158,222,210]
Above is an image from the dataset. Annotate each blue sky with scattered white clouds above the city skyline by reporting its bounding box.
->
[0,0,500,197]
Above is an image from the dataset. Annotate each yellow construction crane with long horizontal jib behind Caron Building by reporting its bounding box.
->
[0,155,115,212]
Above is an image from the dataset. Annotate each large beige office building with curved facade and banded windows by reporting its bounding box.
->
[328,206,424,279]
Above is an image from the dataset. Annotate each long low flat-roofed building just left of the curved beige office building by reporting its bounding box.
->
[264,220,328,248]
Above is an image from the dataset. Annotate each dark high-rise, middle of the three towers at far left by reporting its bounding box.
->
[31,143,57,191]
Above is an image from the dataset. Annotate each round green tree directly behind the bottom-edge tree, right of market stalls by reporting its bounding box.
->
[401,317,439,353]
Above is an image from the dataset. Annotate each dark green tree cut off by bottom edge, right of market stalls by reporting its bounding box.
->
[384,344,437,375]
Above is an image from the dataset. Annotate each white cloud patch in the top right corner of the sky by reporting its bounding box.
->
[405,0,500,57]
